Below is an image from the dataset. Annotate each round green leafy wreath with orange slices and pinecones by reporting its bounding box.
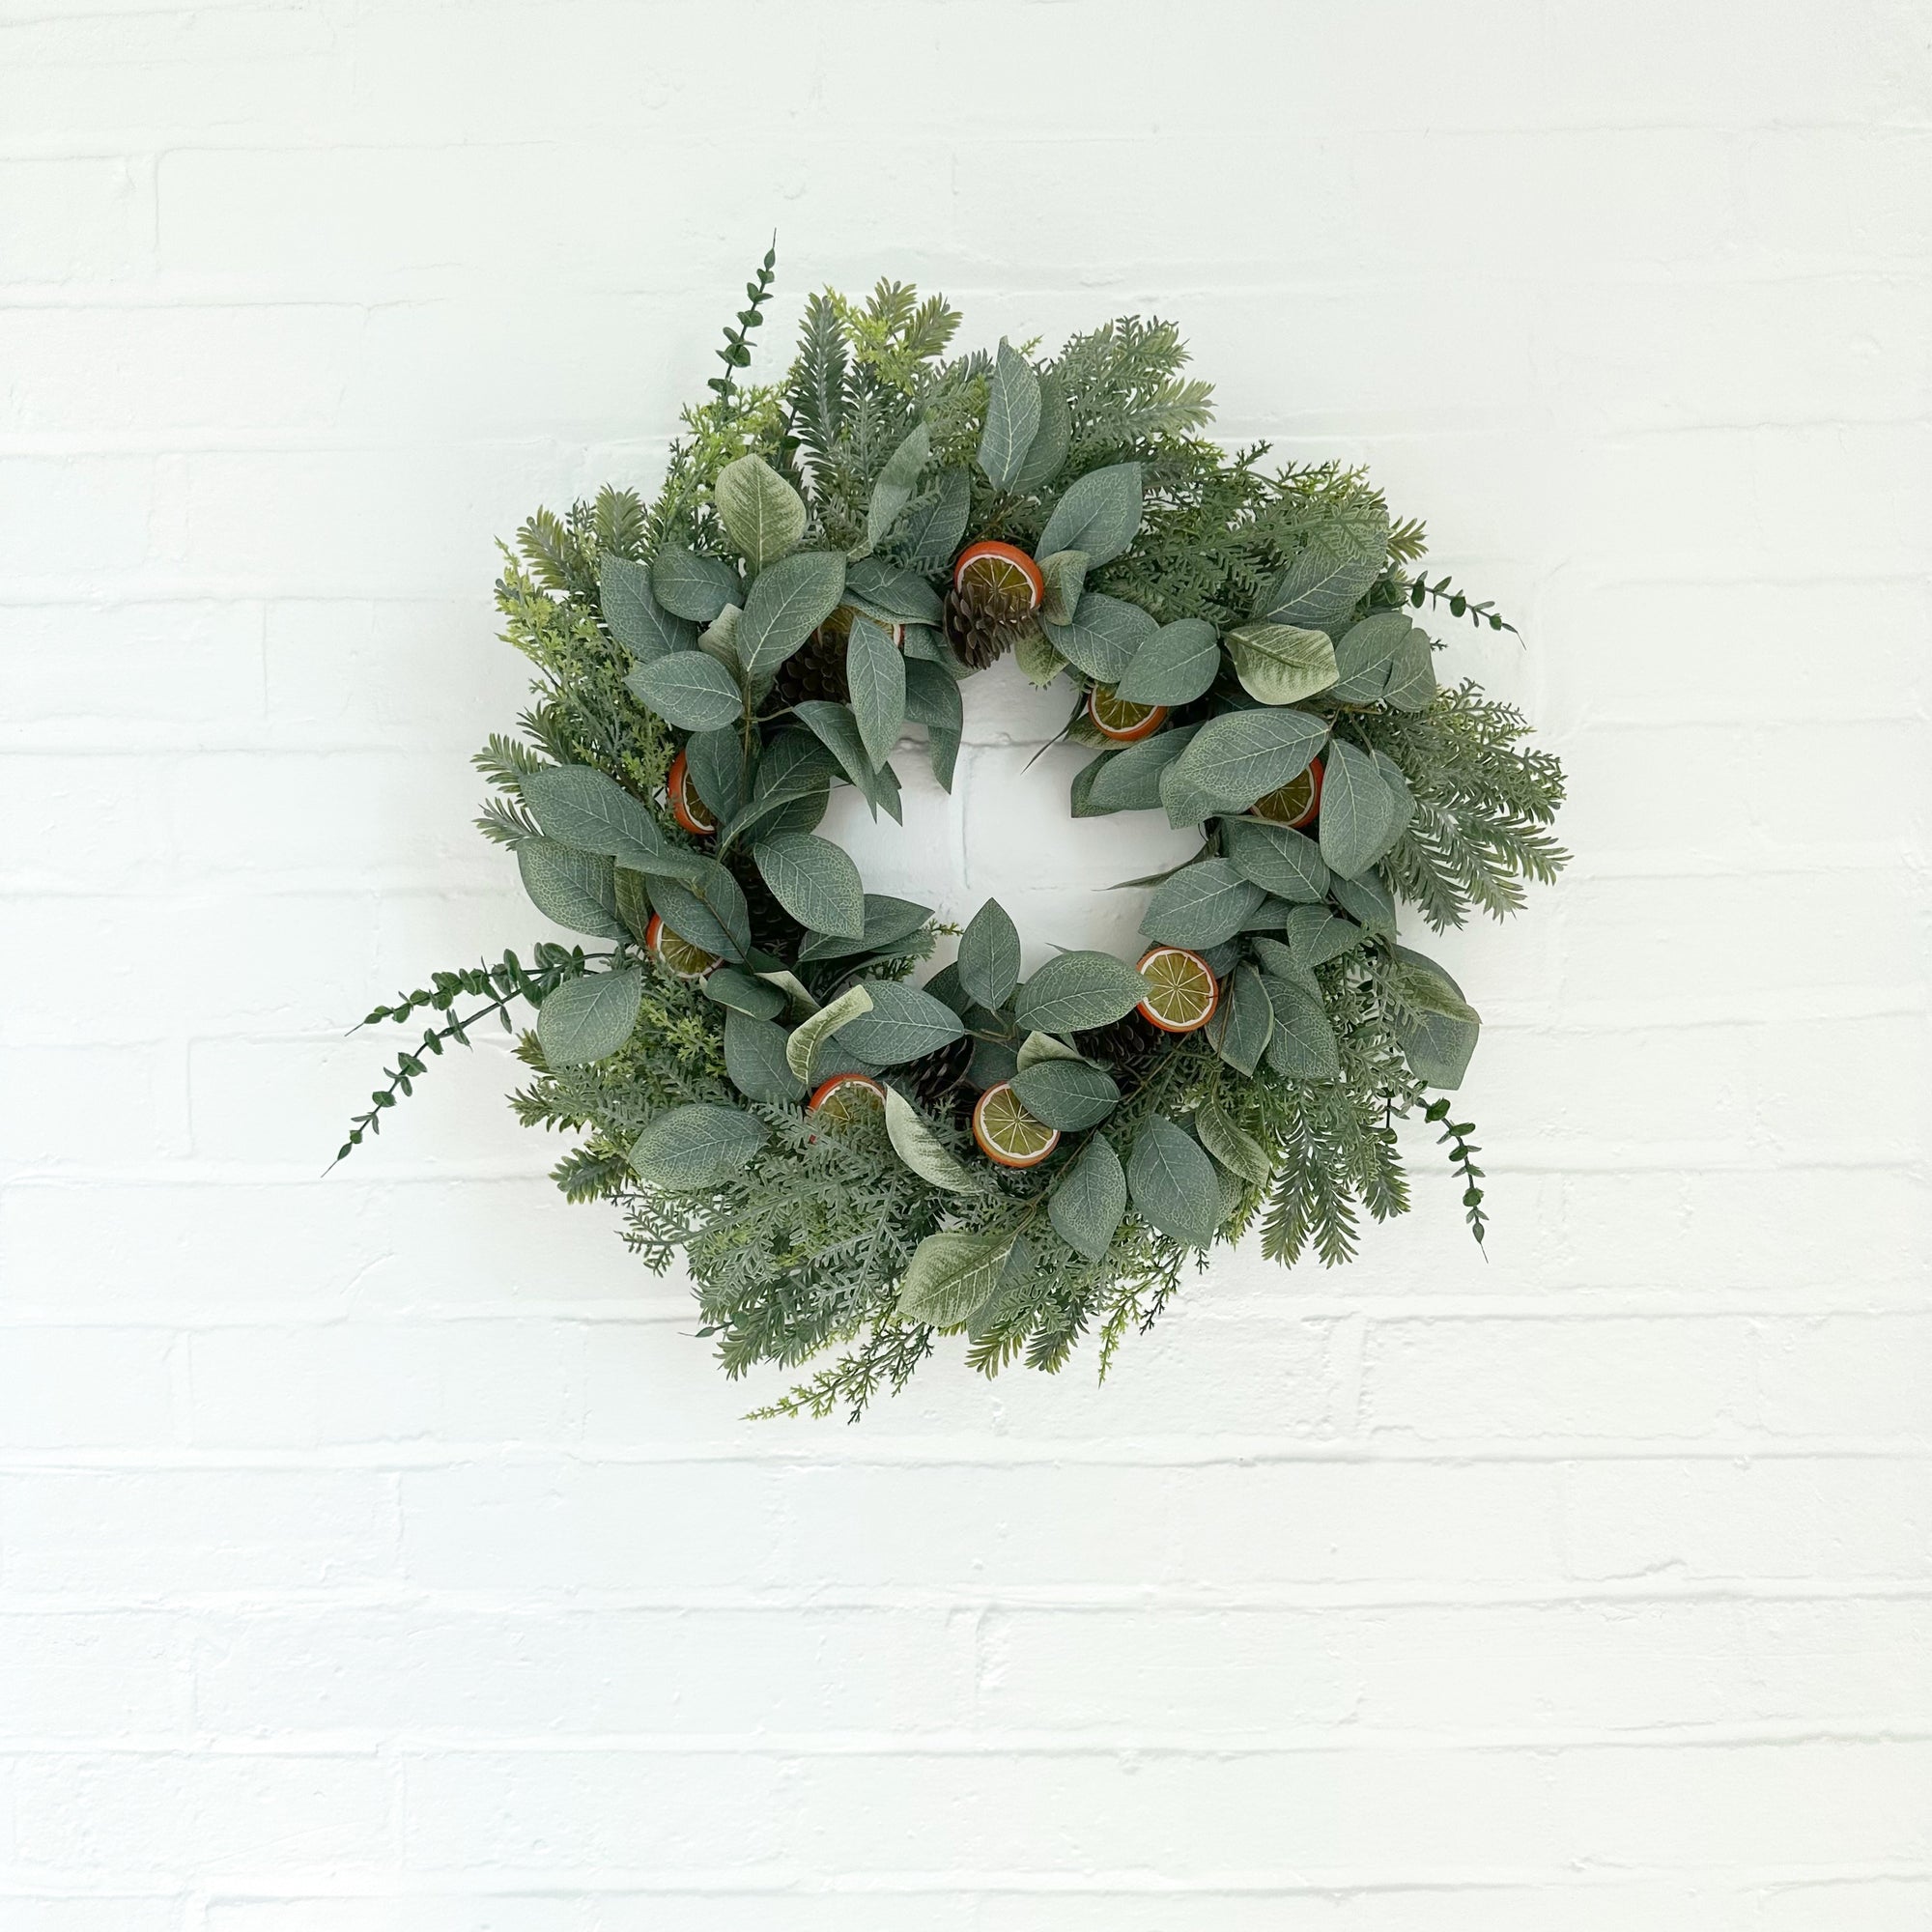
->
[342,253,1565,1414]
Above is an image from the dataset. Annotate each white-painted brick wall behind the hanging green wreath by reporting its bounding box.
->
[0,0,1932,1932]
